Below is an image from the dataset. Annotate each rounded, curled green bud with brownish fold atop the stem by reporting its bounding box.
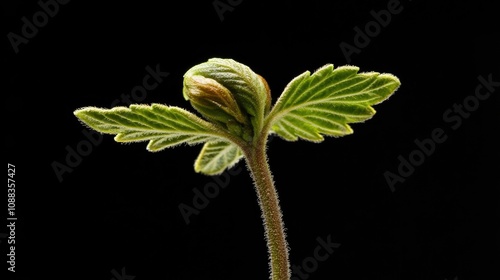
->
[183,58,271,140]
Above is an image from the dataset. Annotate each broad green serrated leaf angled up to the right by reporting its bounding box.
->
[268,64,400,142]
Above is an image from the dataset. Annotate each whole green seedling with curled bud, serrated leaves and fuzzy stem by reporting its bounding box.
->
[74,58,400,280]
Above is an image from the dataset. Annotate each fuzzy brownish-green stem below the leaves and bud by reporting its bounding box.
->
[243,135,290,280]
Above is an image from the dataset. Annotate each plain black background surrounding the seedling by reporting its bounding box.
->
[1,0,500,280]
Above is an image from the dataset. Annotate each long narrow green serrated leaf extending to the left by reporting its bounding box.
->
[74,104,225,152]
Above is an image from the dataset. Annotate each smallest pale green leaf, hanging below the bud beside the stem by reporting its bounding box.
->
[194,141,243,175]
